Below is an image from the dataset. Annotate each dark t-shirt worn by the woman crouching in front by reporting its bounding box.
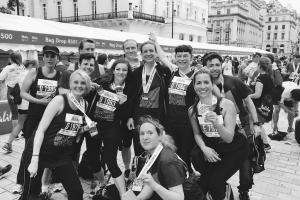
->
[137,147,187,200]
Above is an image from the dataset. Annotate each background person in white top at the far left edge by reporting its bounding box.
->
[0,52,25,126]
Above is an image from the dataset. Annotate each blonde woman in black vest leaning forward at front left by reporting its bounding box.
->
[22,70,90,200]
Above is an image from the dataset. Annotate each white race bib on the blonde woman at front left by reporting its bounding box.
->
[58,113,83,137]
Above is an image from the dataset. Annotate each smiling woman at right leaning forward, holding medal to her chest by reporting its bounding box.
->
[188,68,249,200]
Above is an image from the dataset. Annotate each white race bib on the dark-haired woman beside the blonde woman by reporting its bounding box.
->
[96,90,119,112]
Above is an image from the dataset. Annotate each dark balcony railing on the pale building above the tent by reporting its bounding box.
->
[49,11,165,23]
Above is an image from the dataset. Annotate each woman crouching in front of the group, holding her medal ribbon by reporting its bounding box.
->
[122,116,187,200]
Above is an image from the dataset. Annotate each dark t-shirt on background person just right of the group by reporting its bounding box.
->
[252,74,274,107]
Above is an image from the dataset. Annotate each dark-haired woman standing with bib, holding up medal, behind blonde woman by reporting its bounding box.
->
[89,59,131,198]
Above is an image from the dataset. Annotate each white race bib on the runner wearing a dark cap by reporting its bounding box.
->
[36,79,57,98]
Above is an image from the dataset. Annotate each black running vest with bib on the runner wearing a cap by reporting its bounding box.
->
[28,67,61,118]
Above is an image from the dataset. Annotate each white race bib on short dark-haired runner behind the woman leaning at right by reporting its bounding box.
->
[169,76,192,96]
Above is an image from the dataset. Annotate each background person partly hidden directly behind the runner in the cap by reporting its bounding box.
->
[2,60,37,153]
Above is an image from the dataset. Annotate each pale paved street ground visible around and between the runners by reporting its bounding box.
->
[0,108,300,200]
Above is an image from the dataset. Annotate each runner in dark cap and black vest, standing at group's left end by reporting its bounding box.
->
[17,46,60,189]
